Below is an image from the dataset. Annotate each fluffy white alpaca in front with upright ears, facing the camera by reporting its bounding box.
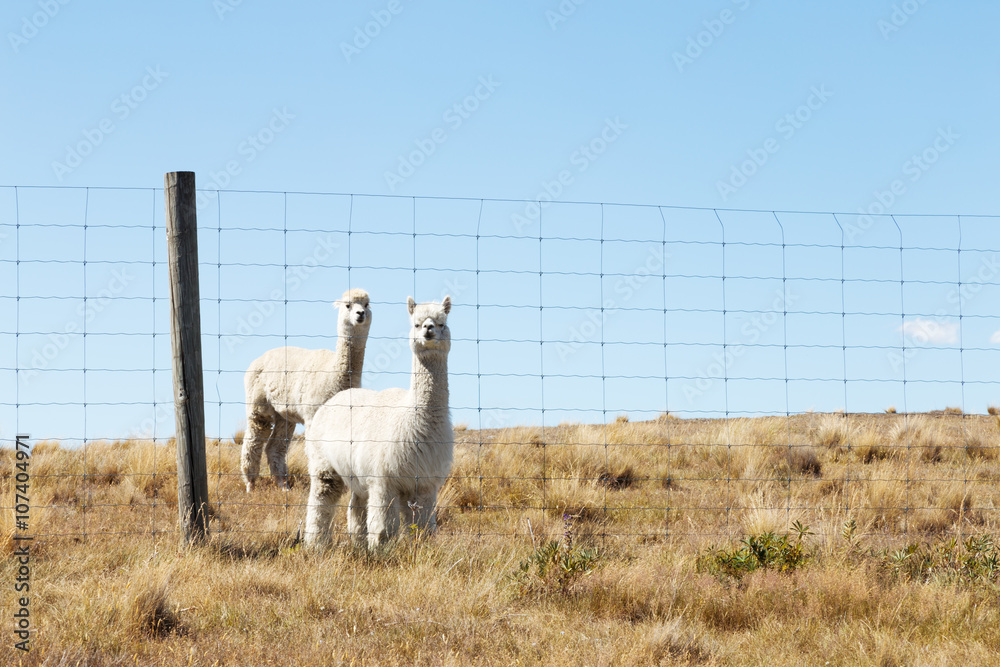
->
[305,296,454,548]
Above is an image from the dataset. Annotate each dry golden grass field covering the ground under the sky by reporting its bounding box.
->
[0,410,1000,665]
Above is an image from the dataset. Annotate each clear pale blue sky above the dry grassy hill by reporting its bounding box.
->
[0,0,1000,439]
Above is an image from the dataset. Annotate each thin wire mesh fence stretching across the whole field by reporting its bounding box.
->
[0,187,1000,542]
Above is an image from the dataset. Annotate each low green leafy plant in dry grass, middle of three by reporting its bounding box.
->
[696,521,813,579]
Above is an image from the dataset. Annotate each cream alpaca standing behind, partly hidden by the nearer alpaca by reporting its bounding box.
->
[240,289,372,493]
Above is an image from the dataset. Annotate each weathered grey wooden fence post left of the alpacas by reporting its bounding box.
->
[163,171,208,545]
